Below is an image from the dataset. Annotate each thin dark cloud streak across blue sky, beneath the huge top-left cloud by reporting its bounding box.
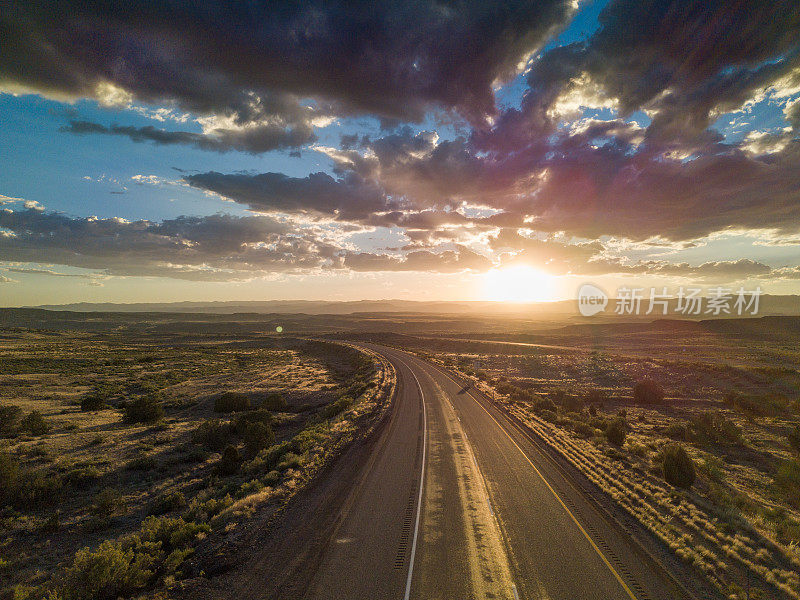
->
[60,120,317,154]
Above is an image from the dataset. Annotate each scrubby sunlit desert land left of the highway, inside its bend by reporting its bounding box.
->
[0,330,394,600]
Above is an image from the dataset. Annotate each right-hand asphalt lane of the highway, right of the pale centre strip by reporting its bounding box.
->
[374,347,683,600]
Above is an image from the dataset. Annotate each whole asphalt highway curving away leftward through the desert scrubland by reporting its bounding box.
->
[305,344,684,600]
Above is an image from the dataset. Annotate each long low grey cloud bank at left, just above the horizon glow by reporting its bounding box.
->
[0,210,339,280]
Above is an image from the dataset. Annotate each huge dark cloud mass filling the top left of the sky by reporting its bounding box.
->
[0,0,573,121]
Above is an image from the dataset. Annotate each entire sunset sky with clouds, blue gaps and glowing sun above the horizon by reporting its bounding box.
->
[0,0,800,306]
